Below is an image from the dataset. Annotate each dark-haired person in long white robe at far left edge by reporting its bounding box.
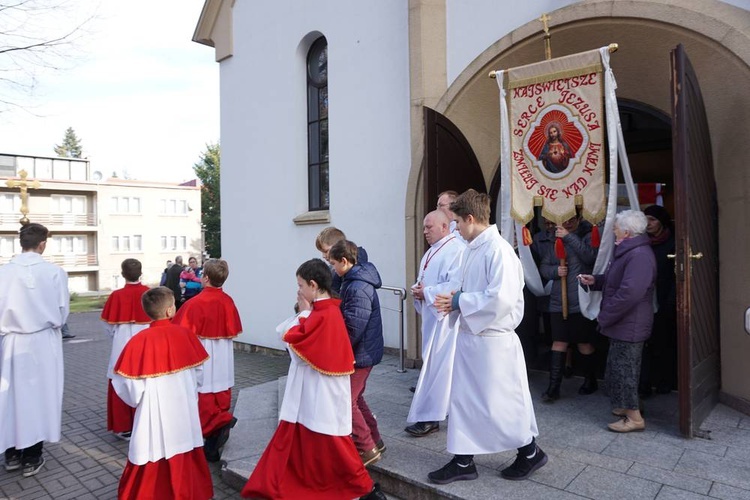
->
[0,223,70,477]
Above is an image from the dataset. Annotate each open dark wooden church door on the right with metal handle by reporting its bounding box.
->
[670,44,721,437]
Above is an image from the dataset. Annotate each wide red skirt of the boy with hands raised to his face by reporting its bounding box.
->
[242,420,373,500]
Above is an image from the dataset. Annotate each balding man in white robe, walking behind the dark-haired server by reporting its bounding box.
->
[404,210,466,437]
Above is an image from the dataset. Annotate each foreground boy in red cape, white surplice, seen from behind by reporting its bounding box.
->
[112,286,213,500]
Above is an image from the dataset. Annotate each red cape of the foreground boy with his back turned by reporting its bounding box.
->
[115,319,208,378]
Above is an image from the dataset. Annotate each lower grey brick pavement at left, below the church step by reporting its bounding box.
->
[0,312,289,500]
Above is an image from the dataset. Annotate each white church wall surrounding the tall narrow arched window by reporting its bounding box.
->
[221,0,411,348]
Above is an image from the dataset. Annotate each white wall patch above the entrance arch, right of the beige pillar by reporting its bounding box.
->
[445,0,580,86]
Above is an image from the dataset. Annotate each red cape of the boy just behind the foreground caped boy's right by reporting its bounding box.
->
[172,287,242,339]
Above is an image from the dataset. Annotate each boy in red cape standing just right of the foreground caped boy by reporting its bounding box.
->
[172,259,242,462]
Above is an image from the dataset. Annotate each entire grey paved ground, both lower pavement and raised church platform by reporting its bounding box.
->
[0,313,750,500]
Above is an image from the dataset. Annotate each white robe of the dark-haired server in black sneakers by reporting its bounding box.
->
[447,225,539,455]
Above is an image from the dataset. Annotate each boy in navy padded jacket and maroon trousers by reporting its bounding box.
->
[328,240,385,465]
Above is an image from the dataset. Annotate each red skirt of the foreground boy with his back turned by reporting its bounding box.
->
[117,448,214,500]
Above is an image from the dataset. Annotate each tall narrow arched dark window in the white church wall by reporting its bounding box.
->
[307,37,330,210]
